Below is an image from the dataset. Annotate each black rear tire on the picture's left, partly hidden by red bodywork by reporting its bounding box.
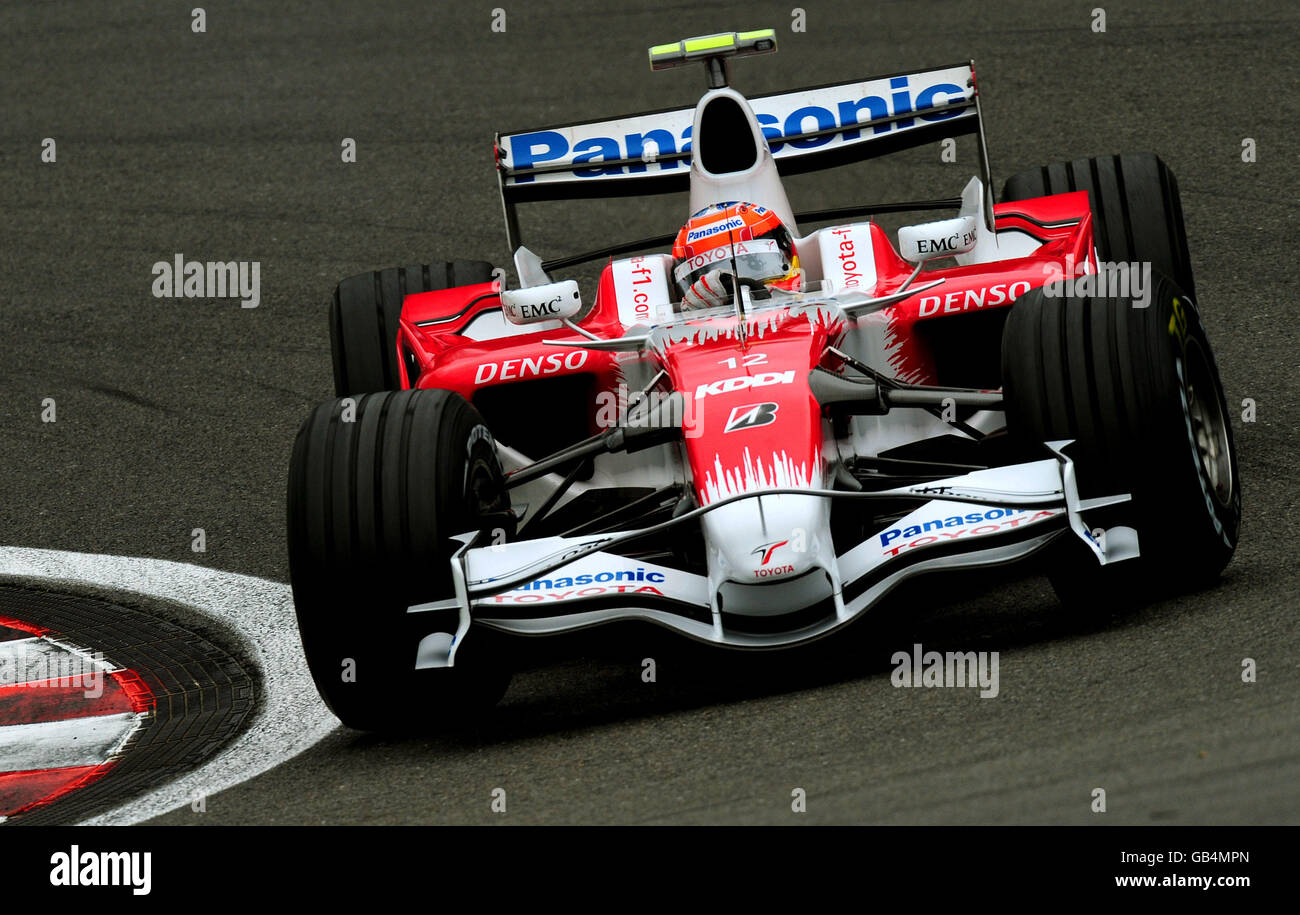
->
[329,260,494,398]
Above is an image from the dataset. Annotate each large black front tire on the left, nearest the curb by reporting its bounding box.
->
[289,390,510,730]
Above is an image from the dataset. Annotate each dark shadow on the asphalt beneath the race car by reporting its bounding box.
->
[347,561,1237,753]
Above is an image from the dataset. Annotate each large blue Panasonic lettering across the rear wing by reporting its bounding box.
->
[507,77,966,183]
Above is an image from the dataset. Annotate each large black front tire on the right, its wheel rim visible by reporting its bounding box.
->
[1002,274,1242,607]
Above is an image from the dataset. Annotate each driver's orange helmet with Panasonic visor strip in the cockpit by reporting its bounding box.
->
[672,200,803,309]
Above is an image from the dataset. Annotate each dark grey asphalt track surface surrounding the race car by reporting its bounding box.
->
[0,0,1300,824]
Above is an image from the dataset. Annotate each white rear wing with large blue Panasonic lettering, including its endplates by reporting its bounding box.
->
[495,61,993,252]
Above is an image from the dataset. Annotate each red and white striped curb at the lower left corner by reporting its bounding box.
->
[0,616,153,823]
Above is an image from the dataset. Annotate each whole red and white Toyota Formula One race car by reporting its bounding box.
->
[289,30,1240,729]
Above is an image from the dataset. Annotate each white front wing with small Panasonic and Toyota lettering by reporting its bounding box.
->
[410,442,1138,668]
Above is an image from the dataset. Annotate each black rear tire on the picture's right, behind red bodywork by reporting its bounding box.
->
[1002,152,1196,299]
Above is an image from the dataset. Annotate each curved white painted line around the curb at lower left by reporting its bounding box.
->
[0,547,339,825]
